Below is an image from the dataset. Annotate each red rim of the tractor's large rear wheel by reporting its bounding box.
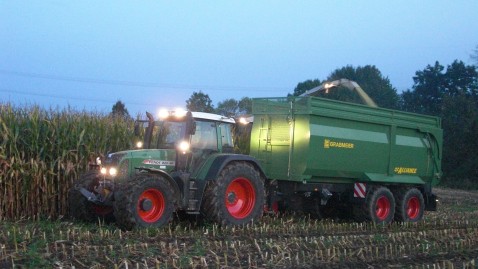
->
[225,178,256,219]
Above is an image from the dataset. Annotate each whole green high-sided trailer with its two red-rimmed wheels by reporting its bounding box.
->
[250,97,442,222]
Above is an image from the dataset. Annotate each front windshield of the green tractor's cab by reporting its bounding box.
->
[151,121,186,149]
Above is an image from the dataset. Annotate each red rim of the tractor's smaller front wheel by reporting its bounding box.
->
[137,189,165,223]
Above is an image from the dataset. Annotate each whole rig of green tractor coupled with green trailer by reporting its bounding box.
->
[68,94,442,229]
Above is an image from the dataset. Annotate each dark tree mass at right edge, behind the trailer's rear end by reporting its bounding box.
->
[401,61,478,188]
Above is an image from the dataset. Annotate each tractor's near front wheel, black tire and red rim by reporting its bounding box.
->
[114,174,176,230]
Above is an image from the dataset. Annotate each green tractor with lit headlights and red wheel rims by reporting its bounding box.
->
[69,111,265,229]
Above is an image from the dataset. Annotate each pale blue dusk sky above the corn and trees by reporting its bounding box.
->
[0,0,478,115]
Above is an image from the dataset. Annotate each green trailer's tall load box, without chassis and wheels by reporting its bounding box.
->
[250,97,442,185]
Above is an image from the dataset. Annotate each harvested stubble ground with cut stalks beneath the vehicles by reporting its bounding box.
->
[0,189,478,268]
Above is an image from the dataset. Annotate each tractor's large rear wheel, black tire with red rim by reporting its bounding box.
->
[201,162,265,226]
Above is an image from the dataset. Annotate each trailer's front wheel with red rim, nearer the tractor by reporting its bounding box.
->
[354,186,395,224]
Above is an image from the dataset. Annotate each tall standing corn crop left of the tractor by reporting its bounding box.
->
[0,104,133,220]
